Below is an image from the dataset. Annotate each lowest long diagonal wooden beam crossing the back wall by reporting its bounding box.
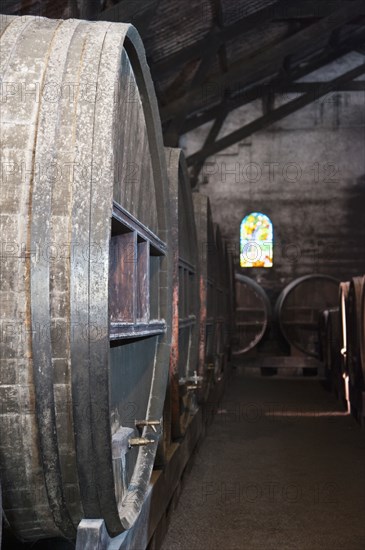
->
[187,63,365,166]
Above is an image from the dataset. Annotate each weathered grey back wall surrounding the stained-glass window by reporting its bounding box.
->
[182,53,365,297]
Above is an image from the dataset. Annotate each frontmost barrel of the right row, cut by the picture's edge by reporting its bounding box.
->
[346,277,365,420]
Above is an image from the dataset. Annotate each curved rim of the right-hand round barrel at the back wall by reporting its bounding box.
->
[275,273,338,357]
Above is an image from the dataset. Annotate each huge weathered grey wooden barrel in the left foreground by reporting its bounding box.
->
[0,17,172,540]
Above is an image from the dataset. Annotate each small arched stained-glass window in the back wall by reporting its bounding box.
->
[240,212,273,267]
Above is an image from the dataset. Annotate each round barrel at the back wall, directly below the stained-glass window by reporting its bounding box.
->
[232,273,271,355]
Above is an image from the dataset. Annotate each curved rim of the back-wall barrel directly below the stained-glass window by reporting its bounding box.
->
[232,273,272,355]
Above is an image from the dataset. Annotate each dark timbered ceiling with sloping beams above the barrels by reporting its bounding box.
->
[0,0,365,184]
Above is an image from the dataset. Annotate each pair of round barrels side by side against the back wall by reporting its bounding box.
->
[233,273,338,357]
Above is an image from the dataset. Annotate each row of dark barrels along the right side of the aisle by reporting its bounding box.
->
[319,276,365,424]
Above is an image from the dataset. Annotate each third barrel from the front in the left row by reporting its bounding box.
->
[193,193,218,401]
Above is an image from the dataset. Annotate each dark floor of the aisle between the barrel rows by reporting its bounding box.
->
[162,369,365,550]
